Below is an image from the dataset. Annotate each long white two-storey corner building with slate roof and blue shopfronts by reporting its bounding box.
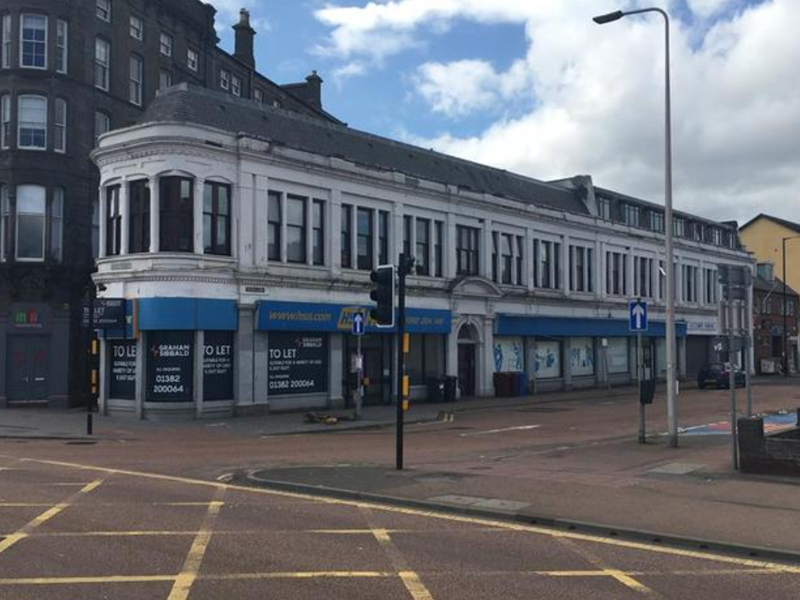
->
[94,85,751,416]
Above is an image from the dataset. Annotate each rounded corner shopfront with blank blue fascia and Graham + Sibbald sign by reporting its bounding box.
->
[101,298,237,418]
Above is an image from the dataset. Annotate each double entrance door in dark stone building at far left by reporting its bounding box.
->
[6,336,50,402]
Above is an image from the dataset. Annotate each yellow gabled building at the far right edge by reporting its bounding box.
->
[739,214,800,290]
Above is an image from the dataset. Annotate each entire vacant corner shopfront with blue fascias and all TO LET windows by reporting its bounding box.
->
[100,298,452,417]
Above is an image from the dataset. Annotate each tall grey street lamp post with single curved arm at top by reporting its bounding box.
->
[594,8,678,448]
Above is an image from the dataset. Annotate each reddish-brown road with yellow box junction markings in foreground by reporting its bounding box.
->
[0,458,800,600]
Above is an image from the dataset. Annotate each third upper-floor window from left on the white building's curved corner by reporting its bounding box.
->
[159,177,194,252]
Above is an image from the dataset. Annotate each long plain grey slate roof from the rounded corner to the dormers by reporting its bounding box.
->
[139,84,589,214]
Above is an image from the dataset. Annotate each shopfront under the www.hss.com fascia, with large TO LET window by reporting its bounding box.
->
[256,301,451,411]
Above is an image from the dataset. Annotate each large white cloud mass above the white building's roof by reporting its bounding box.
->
[318,0,800,219]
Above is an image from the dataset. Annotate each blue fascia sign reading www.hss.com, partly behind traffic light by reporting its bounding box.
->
[258,301,452,334]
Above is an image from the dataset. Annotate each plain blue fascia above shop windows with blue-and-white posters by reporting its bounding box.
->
[495,314,686,338]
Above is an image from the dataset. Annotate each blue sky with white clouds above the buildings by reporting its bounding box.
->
[211,0,800,223]
